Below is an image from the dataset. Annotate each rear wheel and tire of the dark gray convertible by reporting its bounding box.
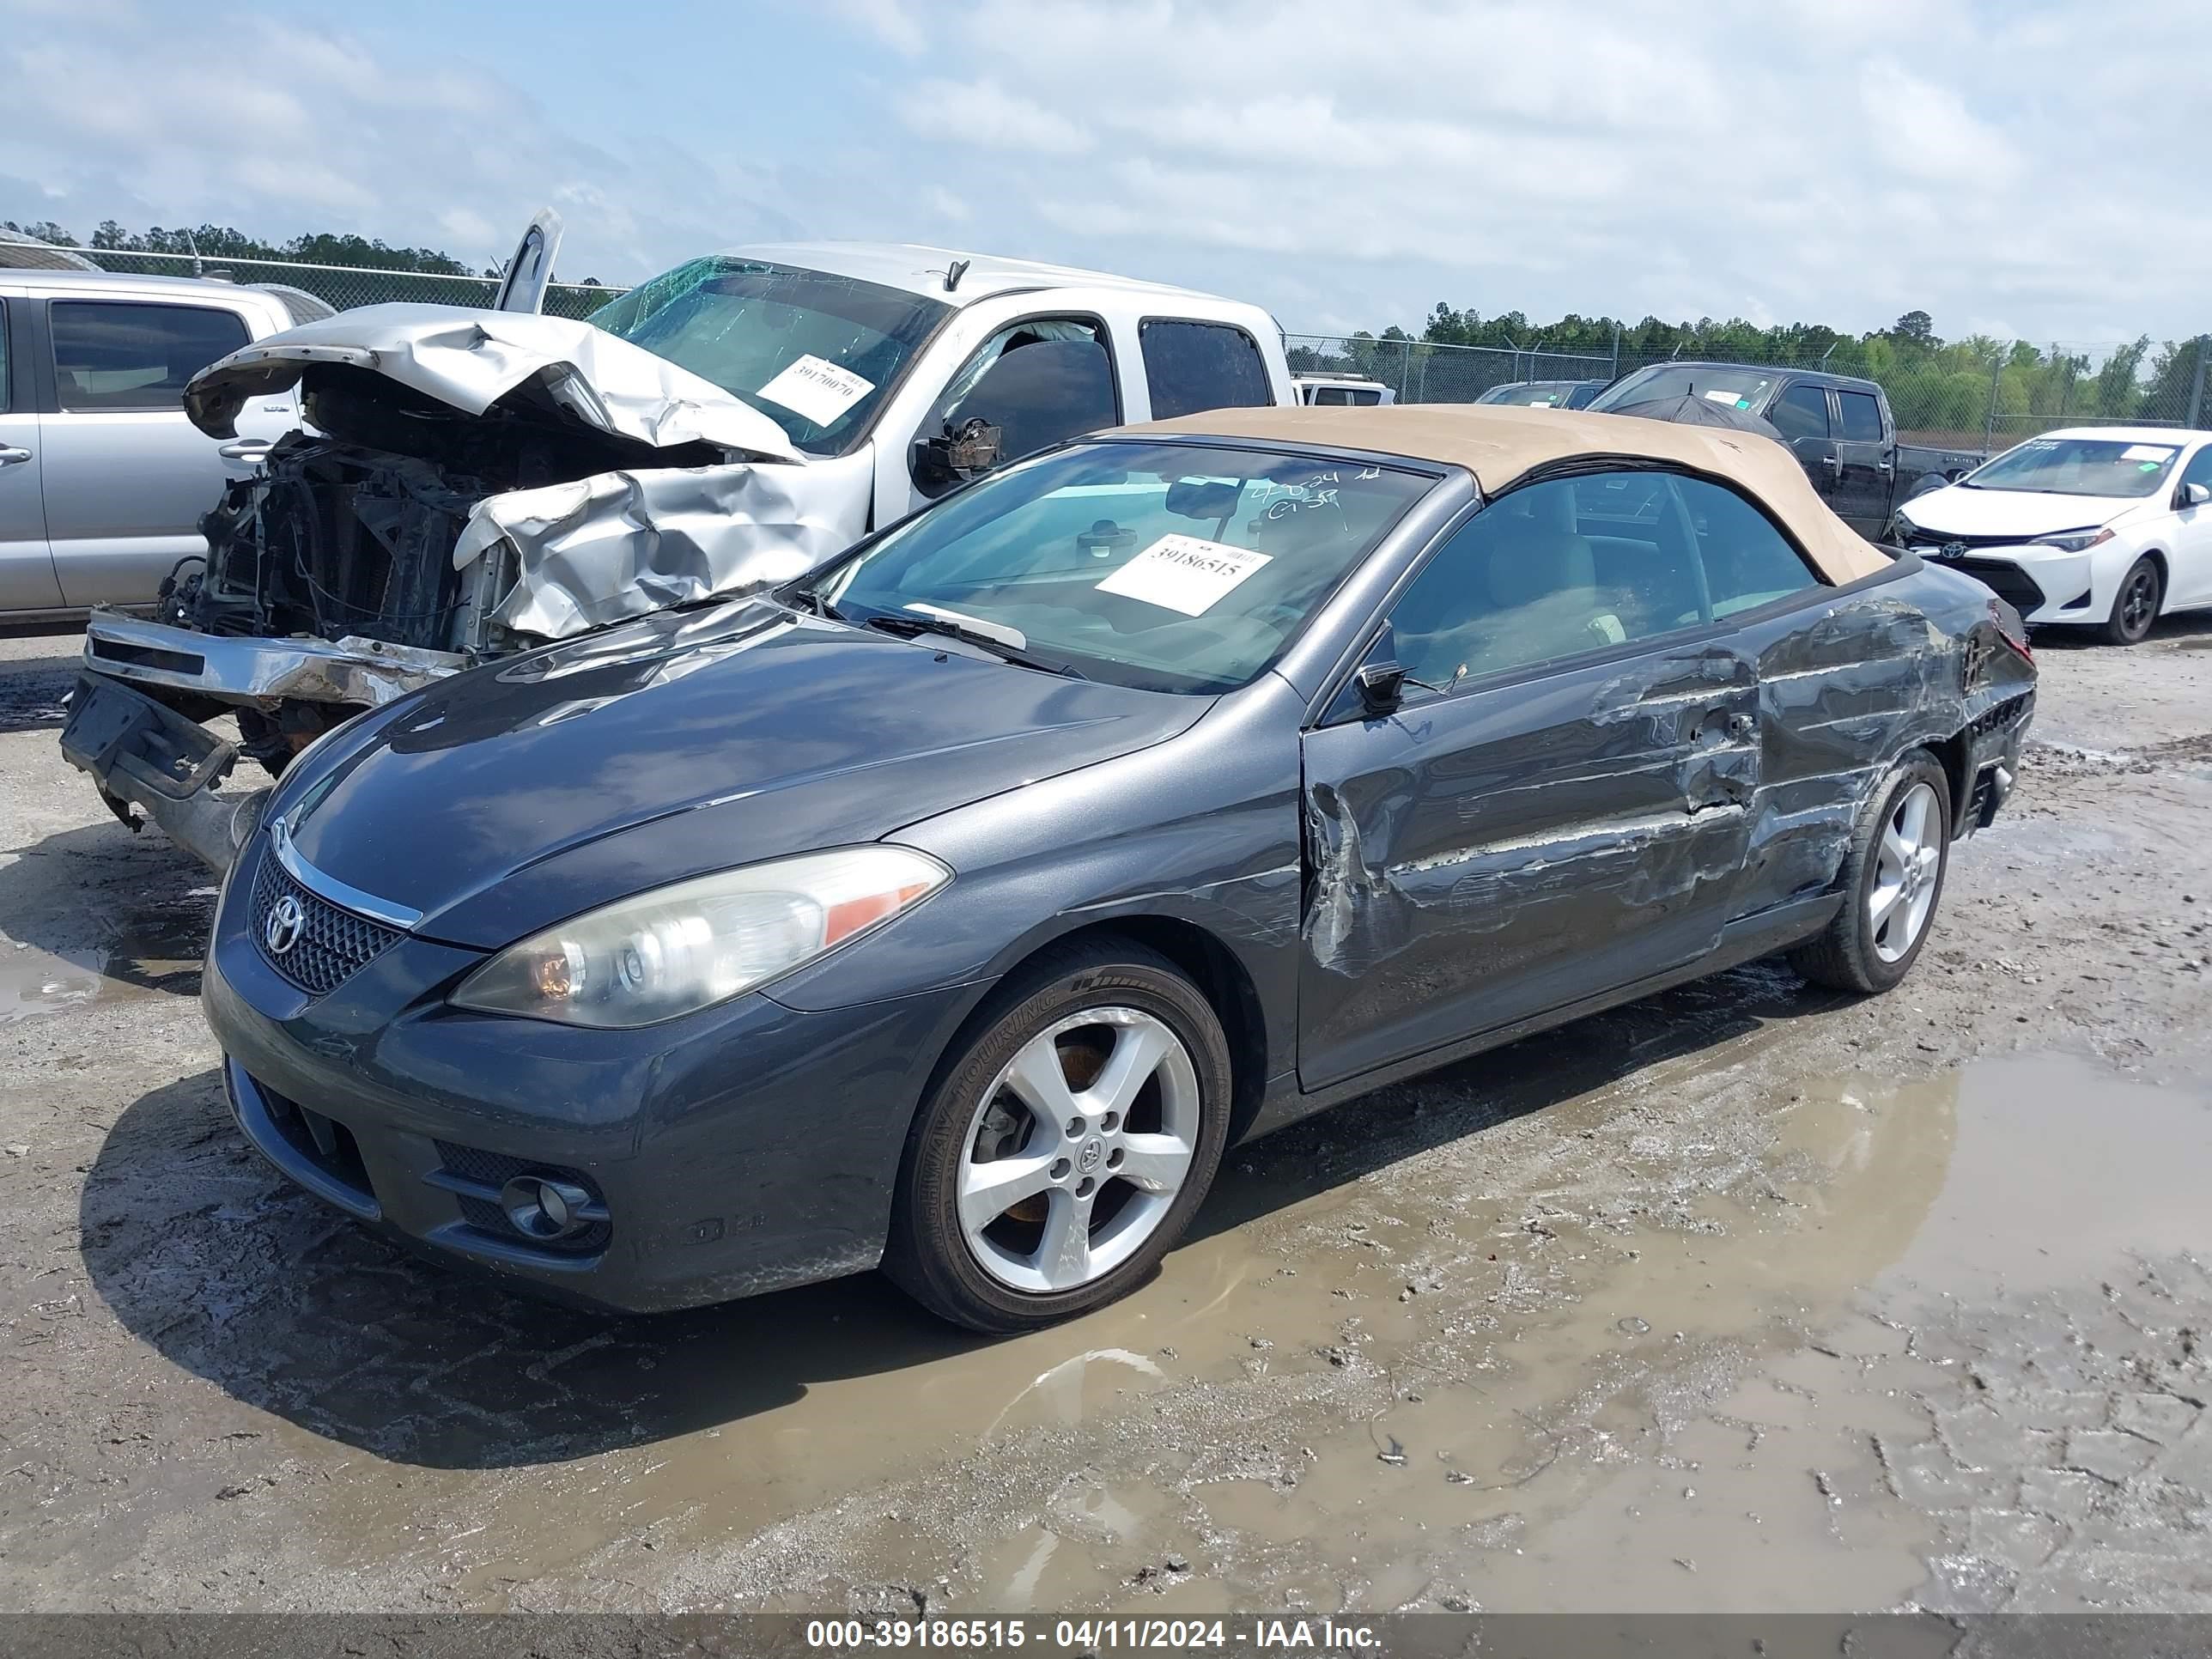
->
[1790,750,1951,994]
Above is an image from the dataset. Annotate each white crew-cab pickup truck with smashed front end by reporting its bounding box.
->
[62,215,1297,867]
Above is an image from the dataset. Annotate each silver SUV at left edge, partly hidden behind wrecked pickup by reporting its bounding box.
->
[0,270,330,622]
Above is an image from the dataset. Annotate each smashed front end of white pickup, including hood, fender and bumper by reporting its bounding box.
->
[62,305,836,867]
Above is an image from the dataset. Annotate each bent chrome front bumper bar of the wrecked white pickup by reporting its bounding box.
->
[84,611,467,708]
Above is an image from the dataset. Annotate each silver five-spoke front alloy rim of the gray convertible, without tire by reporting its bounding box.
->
[957,1006,1201,1294]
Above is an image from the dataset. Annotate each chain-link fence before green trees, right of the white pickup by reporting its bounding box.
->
[1283,334,2212,453]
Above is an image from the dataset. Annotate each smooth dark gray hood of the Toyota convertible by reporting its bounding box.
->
[276,602,1210,949]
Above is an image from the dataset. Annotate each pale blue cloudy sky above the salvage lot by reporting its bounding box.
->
[0,0,2212,343]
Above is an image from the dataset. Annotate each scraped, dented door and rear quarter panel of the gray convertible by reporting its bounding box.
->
[1298,571,2033,1088]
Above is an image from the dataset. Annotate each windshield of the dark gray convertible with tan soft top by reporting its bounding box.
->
[792,442,1436,692]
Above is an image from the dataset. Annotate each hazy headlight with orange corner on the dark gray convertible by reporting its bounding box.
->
[452,845,953,1029]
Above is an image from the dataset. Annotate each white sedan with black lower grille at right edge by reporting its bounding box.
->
[1896,427,2212,646]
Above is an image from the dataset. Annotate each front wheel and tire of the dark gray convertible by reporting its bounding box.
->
[883,940,1230,1332]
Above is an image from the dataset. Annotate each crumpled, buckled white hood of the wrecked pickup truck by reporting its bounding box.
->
[184,305,801,462]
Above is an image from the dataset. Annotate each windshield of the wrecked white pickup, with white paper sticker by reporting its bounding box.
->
[591,254,951,456]
